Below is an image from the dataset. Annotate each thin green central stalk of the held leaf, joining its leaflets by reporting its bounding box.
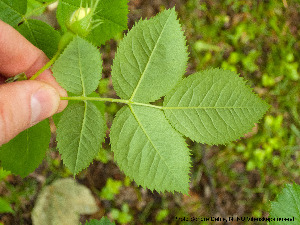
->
[60,96,163,109]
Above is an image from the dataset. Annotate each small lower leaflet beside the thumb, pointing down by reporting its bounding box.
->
[57,101,106,175]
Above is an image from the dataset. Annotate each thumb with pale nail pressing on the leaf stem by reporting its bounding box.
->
[0,80,60,146]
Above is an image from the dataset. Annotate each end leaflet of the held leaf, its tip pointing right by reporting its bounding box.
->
[163,69,269,145]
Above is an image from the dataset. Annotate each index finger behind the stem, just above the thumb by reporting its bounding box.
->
[0,20,68,112]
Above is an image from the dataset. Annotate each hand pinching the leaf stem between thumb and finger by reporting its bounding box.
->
[0,20,67,146]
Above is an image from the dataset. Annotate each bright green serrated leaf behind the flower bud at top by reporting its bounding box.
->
[56,0,128,46]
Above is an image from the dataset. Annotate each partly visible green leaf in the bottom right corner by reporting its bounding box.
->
[270,183,300,225]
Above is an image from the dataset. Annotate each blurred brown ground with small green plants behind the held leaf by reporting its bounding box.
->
[0,0,300,225]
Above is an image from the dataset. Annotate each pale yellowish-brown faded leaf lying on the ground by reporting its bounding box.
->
[32,178,98,225]
